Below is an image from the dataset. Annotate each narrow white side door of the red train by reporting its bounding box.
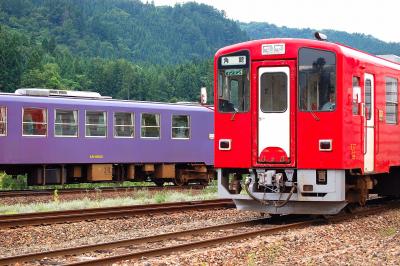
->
[364,74,375,172]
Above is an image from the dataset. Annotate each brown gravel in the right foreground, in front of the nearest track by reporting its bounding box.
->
[129,210,400,265]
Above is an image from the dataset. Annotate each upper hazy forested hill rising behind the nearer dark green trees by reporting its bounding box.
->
[0,0,247,64]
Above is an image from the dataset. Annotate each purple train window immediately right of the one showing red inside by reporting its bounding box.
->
[54,109,78,137]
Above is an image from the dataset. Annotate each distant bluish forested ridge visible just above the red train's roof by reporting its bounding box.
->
[240,22,400,55]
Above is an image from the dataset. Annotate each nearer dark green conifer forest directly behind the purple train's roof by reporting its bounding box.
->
[0,24,212,101]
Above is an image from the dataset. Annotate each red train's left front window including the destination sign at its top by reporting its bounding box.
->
[218,52,250,113]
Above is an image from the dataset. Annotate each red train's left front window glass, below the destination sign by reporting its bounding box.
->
[218,68,250,113]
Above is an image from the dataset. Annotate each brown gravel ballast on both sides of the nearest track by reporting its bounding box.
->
[0,204,400,266]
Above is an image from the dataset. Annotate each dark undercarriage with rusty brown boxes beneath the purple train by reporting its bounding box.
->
[0,163,215,186]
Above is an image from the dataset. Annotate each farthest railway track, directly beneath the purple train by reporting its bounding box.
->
[0,185,205,198]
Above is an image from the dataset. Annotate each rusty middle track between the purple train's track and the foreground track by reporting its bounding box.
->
[0,199,234,228]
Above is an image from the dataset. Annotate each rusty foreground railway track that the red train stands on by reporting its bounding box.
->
[0,202,399,265]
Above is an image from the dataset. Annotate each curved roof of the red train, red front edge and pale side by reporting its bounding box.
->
[216,38,400,70]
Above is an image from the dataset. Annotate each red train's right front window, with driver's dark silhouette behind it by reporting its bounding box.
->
[299,48,336,112]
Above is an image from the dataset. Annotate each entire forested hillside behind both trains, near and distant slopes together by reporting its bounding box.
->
[0,0,400,102]
